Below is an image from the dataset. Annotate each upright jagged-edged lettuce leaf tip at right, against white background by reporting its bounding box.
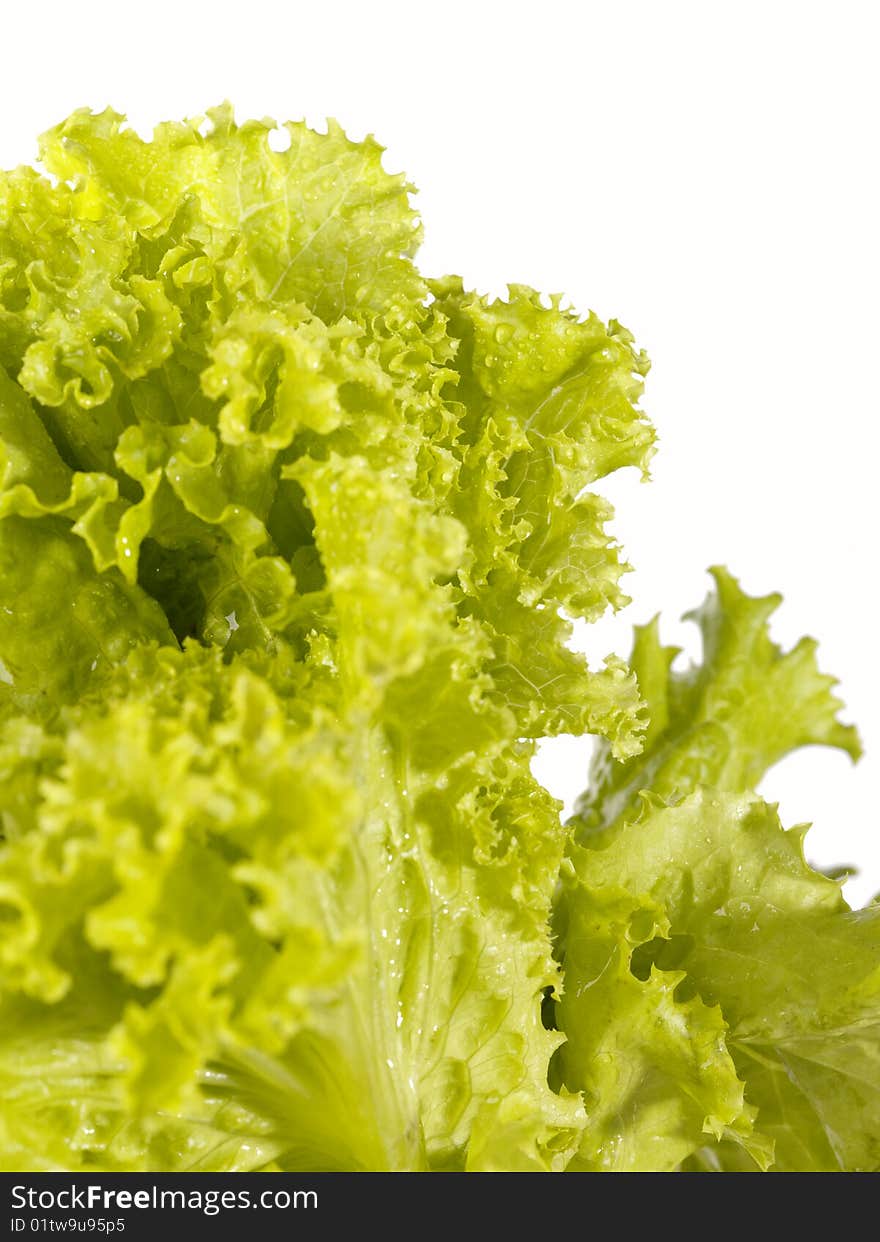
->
[573,568,861,837]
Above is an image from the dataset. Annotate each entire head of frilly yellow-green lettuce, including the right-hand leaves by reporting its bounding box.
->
[0,107,880,1171]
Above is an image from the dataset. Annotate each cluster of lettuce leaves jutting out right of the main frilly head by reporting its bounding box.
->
[555,570,880,1170]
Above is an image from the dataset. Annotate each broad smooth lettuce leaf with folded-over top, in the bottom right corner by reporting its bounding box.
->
[566,791,880,1170]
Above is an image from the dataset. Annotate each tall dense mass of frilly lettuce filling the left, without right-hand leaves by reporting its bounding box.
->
[0,107,652,1170]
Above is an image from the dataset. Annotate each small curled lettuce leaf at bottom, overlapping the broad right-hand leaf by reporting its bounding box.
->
[556,871,767,1172]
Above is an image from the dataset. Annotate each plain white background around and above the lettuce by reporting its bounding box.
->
[0,0,880,902]
